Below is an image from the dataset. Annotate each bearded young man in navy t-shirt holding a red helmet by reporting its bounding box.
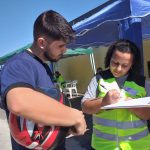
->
[1,10,86,150]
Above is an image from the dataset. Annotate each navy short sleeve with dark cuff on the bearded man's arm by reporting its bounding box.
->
[1,59,36,108]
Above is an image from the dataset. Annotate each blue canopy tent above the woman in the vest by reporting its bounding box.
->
[70,0,150,48]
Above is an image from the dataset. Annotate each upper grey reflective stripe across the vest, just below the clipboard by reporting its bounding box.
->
[93,116,146,129]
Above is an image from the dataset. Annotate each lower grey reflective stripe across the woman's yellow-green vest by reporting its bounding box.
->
[93,128,149,141]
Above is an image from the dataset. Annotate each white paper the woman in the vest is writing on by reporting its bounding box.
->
[100,97,150,109]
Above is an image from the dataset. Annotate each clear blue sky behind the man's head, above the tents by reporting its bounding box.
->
[0,0,107,57]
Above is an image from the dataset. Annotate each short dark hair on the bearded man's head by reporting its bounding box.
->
[33,10,75,43]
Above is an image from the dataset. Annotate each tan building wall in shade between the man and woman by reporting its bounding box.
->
[58,55,93,93]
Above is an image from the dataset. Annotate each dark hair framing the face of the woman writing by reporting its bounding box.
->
[105,39,142,75]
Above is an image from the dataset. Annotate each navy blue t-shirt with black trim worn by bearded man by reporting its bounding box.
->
[0,50,58,150]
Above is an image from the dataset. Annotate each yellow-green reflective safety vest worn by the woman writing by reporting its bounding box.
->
[92,70,150,150]
